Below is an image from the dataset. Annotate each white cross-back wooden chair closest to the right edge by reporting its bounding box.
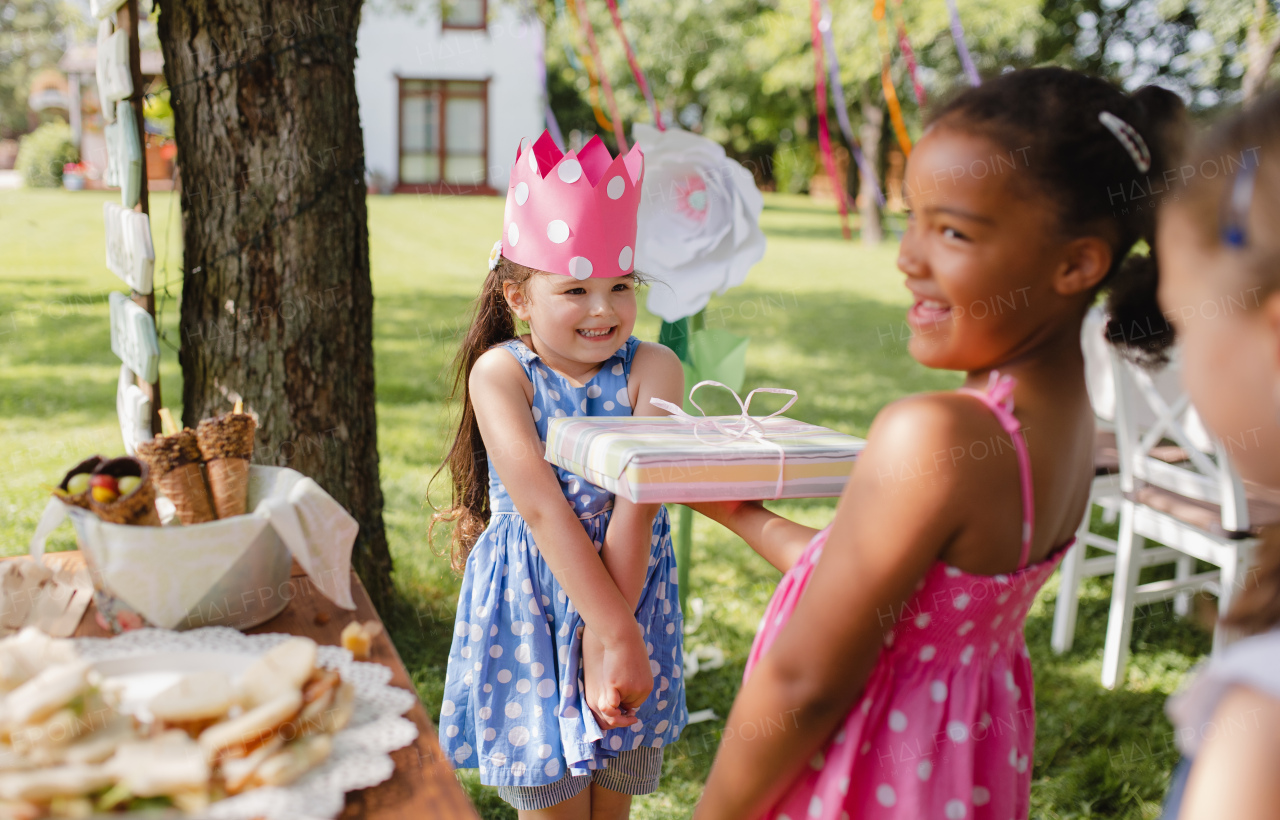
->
[1102,351,1280,688]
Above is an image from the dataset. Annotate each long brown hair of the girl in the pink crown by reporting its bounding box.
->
[426,257,538,572]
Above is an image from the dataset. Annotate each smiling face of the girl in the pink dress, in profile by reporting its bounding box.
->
[897,127,1111,371]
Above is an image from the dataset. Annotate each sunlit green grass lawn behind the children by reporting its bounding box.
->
[0,191,1210,820]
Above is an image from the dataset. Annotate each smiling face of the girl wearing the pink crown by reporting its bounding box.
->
[503,272,636,376]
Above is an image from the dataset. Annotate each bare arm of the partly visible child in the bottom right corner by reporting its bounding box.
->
[1178,686,1280,820]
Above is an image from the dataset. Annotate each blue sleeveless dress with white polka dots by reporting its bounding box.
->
[440,336,689,787]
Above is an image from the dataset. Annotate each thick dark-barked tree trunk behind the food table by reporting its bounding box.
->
[157,0,392,604]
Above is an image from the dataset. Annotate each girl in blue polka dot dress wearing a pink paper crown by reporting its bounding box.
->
[433,132,687,819]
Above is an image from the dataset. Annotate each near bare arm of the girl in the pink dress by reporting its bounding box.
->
[695,397,963,820]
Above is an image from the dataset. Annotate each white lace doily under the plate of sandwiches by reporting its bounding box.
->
[76,627,417,820]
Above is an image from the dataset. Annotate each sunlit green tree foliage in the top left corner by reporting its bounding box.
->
[0,0,88,137]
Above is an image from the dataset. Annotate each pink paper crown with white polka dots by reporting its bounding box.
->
[502,130,644,279]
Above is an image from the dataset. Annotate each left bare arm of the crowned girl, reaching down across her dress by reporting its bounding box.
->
[468,349,652,654]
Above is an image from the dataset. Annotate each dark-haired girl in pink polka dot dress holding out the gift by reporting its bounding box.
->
[694,69,1181,820]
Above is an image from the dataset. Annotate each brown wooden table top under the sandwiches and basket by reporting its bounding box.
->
[45,551,476,820]
